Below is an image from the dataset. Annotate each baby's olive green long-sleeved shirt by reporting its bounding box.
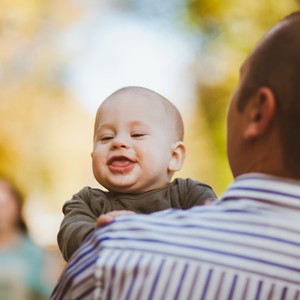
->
[57,178,217,261]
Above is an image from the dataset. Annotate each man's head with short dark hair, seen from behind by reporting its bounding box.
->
[227,12,300,179]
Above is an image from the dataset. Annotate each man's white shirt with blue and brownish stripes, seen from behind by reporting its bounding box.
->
[51,173,300,300]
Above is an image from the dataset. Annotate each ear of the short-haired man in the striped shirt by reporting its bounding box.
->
[244,87,276,140]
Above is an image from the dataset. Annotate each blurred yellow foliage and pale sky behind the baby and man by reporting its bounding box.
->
[0,0,300,288]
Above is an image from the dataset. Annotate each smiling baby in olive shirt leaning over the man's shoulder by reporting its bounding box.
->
[58,87,216,261]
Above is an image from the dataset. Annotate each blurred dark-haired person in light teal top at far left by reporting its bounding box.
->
[0,176,52,300]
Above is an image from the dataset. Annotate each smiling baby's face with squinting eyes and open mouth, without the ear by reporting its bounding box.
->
[92,92,174,193]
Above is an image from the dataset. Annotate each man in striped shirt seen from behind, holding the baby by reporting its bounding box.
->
[52,12,300,300]
